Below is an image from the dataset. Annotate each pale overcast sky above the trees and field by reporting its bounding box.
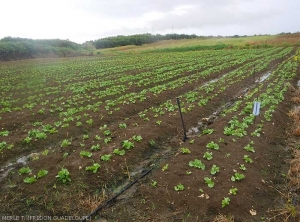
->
[0,0,300,43]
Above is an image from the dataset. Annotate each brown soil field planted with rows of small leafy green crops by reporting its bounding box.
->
[0,47,299,221]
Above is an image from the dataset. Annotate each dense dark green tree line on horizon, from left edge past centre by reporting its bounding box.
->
[0,33,207,61]
